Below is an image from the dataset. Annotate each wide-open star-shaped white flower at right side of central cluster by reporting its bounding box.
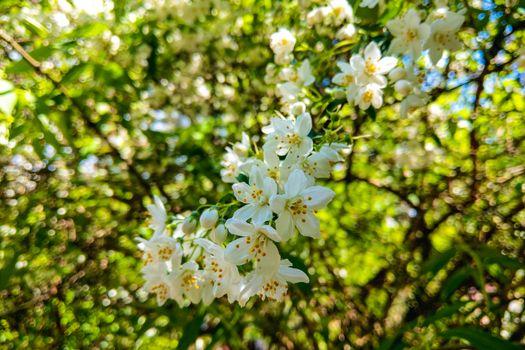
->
[270,170,335,240]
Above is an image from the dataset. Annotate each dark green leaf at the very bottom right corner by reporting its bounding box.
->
[440,327,522,350]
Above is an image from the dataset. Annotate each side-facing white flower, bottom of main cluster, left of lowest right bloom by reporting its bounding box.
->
[195,238,241,303]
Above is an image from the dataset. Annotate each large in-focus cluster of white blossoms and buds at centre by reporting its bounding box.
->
[139,112,345,307]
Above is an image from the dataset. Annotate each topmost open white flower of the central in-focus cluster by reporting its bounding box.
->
[263,113,313,157]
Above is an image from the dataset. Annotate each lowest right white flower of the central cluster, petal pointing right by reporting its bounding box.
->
[239,245,309,306]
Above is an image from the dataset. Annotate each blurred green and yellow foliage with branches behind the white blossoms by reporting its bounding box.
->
[0,0,525,350]
